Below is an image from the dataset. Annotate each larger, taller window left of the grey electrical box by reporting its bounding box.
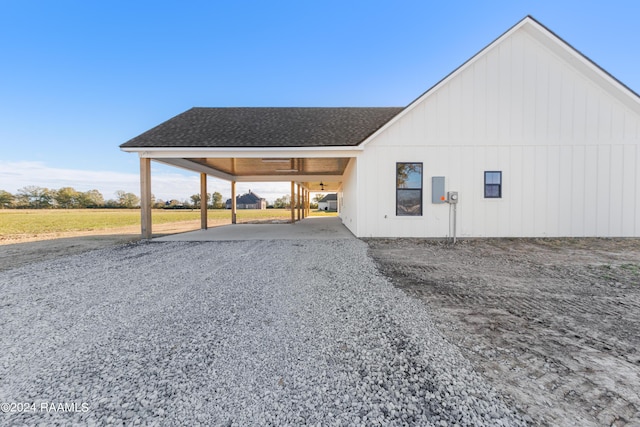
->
[396,163,422,216]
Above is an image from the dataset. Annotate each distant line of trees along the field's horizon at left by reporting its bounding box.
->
[0,185,230,209]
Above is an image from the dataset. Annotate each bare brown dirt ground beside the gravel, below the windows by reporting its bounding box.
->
[367,239,640,426]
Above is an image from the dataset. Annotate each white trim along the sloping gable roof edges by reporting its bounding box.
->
[362,15,640,147]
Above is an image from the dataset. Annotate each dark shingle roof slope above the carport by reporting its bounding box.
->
[120,107,403,148]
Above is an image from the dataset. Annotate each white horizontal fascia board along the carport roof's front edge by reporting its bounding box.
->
[121,146,362,159]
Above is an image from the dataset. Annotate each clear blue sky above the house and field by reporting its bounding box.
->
[0,0,640,200]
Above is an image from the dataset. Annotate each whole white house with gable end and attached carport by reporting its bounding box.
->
[121,17,640,241]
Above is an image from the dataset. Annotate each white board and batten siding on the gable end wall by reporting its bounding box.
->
[356,21,640,237]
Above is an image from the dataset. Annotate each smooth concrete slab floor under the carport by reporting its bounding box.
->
[153,217,355,242]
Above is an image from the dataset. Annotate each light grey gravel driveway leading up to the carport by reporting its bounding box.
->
[0,239,527,426]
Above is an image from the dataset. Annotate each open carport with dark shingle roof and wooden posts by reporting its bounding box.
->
[120,108,402,239]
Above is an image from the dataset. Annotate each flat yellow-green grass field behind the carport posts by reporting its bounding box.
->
[0,209,336,236]
